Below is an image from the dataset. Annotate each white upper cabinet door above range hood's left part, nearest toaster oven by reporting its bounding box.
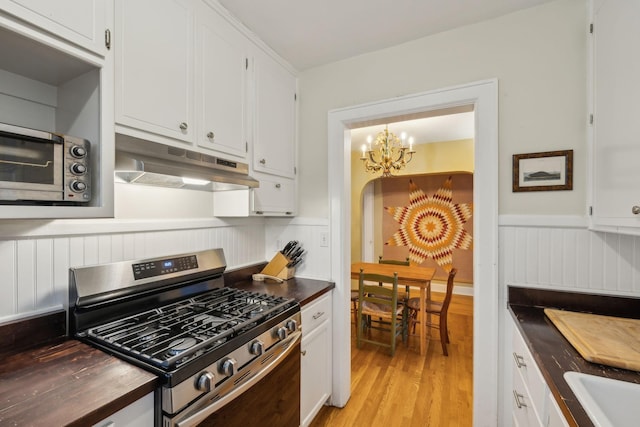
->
[114,0,195,142]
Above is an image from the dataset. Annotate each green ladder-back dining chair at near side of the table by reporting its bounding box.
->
[356,269,408,356]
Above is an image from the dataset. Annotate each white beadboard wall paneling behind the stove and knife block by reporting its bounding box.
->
[0,218,330,323]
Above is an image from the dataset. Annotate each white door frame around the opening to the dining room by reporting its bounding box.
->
[328,79,499,426]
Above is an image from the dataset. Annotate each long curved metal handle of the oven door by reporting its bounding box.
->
[171,330,302,427]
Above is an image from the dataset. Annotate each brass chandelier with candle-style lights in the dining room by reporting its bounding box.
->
[360,126,415,177]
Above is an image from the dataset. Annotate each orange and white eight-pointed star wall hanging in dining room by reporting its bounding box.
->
[385,177,473,272]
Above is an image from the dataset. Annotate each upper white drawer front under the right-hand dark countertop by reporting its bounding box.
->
[512,329,547,419]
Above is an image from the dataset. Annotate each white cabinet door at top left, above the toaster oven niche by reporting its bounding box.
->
[2,0,111,56]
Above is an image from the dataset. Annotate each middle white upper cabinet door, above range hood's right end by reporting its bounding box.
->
[195,4,248,159]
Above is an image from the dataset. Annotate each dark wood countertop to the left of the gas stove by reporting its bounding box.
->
[0,312,158,427]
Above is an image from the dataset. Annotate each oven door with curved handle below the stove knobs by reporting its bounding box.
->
[168,331,302,427]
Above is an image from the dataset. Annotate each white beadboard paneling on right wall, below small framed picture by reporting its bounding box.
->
[499,220,640,296]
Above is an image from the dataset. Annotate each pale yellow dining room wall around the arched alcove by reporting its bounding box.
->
[351,139,473,261]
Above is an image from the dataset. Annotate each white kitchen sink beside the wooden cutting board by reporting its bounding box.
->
[564,371,640,427]
